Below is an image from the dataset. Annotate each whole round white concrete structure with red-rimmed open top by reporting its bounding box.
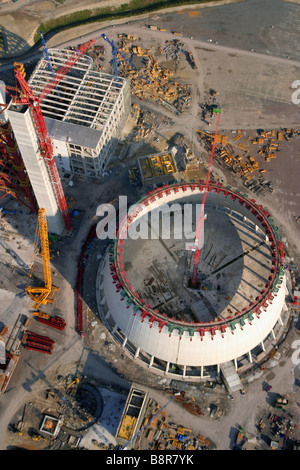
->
[97,181,286,380]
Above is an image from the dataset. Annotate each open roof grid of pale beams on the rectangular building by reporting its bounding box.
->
[30,49,125,131]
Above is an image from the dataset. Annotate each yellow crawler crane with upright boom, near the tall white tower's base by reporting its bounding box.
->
[25,209,58,310]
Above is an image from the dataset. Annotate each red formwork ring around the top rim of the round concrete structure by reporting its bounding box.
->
[114,181,283,332]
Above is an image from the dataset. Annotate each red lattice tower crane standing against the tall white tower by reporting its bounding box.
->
[15,39,95,232]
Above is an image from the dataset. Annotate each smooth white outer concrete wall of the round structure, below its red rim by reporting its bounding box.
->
[100,252,286,367]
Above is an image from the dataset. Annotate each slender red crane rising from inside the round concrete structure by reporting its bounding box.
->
[191,112,221,287]
